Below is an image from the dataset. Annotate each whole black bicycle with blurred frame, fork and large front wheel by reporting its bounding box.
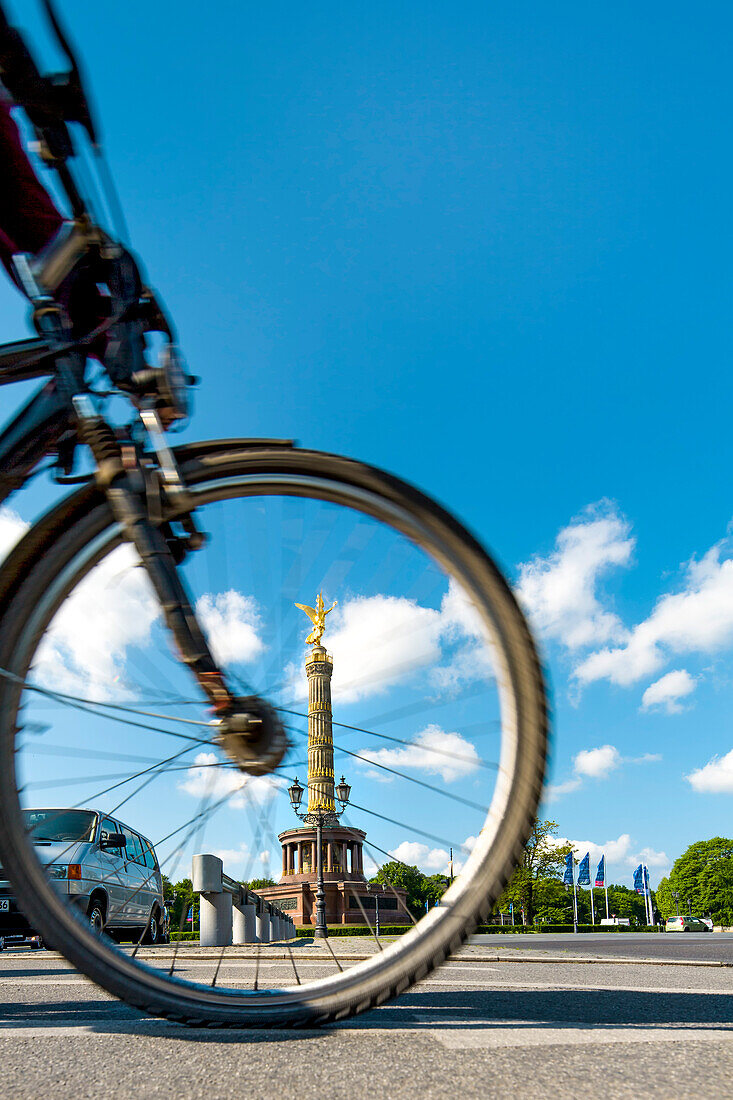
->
[0,0,548,1027]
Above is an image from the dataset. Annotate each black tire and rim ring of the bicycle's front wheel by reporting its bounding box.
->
[0,440,549,1027]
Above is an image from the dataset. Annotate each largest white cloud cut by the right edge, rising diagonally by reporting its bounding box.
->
[575,543,733,685]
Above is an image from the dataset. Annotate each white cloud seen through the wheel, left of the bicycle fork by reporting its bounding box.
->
[32,543,161,700]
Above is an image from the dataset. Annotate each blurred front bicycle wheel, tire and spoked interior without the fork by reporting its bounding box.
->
[0,441,548,1027]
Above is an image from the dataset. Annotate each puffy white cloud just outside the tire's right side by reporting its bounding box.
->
[518,503,634,649]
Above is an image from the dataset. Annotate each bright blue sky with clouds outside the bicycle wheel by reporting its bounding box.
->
[0,0,733,881]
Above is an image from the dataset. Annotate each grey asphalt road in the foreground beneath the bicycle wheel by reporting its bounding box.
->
[0,937,733,1100]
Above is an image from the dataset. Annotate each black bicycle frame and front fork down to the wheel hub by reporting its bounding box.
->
[0,0,287,774]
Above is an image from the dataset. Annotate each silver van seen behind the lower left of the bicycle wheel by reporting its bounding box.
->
[0,809,166,944]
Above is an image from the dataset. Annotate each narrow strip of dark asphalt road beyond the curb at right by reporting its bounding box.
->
[464,932,733,965]
